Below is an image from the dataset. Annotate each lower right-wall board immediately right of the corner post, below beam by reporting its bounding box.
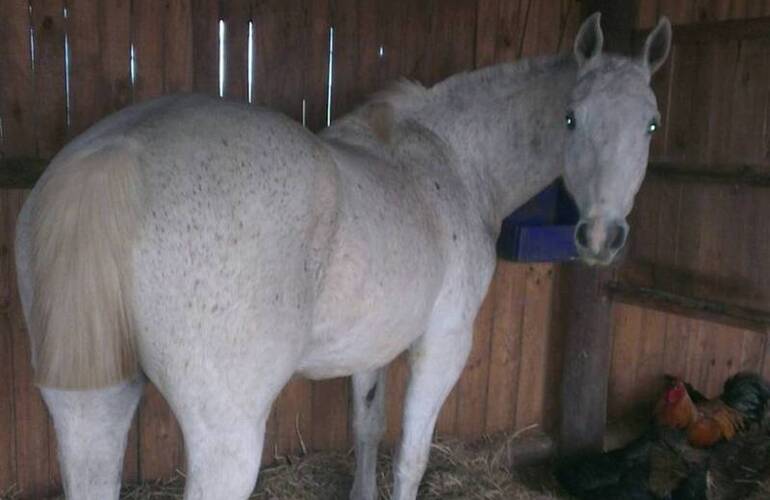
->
[607,304,644,418]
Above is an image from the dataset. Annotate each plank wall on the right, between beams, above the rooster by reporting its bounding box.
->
[609,0,770,417]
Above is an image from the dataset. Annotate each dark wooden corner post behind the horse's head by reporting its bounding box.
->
[559,0,636,455]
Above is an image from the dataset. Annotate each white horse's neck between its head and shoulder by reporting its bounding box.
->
[415,56,577,231]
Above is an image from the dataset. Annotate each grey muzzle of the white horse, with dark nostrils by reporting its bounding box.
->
[575,218,628,266]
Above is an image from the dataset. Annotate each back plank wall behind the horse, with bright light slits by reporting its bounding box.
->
[0,0,579,498]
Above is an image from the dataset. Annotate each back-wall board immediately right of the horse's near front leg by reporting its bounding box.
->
[456,262,502,439]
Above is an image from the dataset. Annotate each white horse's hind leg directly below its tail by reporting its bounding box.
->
[41,377,144,500]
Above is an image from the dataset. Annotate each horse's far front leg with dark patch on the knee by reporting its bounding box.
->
[350,368,385,500]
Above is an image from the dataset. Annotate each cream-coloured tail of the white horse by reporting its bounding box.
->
[28,145,144,389]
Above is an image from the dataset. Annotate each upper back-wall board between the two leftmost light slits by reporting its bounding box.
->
[30,0,67,158]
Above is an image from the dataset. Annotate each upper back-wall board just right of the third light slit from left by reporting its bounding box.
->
[131,0,165,102]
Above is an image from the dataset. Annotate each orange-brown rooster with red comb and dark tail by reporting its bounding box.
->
[655,373,770,448]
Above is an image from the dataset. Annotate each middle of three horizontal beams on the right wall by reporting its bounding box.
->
[647,162,770,187]
